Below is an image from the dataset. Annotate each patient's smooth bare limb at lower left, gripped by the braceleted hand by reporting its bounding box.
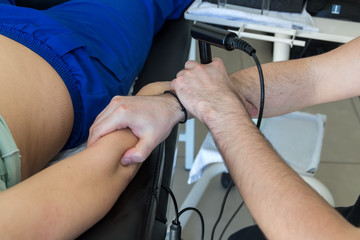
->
[0,130,139,239]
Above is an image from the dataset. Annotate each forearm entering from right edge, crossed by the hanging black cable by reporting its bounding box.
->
[230,38,360,117]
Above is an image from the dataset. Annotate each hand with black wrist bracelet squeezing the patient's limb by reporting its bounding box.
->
[88,94,184,165]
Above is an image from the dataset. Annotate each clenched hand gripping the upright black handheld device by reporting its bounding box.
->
[170,58,257,124]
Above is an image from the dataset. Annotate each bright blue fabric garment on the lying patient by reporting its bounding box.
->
[0,0,192,148]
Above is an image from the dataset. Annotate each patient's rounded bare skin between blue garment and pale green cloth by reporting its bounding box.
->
[0,35,74,179]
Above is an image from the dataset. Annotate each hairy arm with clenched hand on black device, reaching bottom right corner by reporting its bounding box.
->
[171,59,360,239]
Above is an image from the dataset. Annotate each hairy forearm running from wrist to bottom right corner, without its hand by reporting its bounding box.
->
[205,102,360,239]
